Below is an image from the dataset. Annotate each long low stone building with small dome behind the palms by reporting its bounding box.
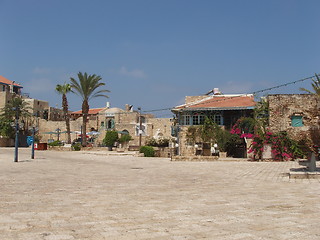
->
[52,103,171,146]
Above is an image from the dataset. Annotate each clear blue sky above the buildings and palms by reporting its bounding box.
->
[0,0,320,117]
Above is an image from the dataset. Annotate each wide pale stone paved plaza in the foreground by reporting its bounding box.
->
[0,148,320,240]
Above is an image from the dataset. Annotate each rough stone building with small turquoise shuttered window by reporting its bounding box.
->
[267,94,320,145]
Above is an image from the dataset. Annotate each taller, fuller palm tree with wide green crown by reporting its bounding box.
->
[70,72,110,146]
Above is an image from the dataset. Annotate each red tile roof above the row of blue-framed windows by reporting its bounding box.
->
[174,95,256,110]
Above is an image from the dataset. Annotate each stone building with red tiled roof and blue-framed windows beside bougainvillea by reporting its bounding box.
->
[172,89,256,156]
